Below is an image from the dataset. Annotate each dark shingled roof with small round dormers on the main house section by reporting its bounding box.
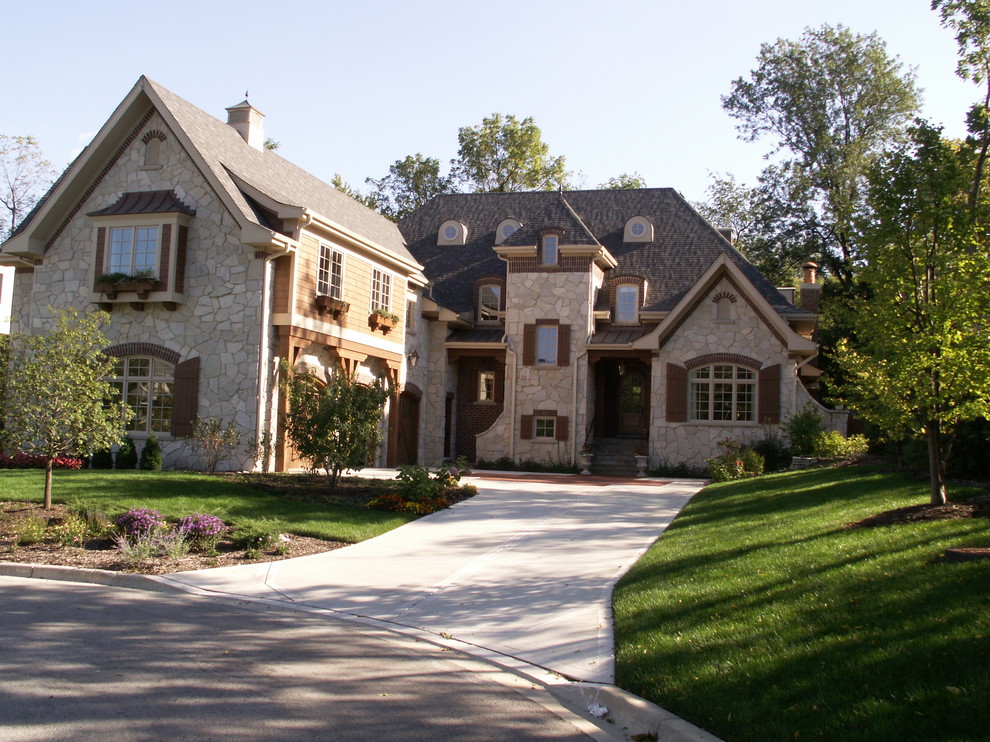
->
[399,188,805,316]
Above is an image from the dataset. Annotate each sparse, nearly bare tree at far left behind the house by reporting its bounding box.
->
[0,134,56,241]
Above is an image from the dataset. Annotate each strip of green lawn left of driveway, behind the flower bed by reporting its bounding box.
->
[0,469,416,543]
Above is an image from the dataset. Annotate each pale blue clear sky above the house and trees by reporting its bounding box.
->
[0,0,979,200]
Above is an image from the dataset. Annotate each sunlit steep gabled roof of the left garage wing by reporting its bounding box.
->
[5,76,417,276]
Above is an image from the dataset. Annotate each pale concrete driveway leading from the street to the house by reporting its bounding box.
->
[157,472,704,683]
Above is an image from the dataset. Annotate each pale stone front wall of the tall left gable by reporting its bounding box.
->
[23,114,263,470]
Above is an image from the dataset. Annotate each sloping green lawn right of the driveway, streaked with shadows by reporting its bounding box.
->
[614,467,990,742]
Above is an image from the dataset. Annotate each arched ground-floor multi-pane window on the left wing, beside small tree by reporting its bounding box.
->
[111,356,175,433]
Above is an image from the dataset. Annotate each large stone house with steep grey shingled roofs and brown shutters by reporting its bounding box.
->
[0,77,840,469]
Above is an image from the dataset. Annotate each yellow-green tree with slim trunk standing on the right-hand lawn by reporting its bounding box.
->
[839,123,990,504]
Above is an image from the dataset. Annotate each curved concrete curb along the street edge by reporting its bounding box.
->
[0,562,722,742]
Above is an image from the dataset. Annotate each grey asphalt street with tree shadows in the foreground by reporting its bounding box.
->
[0,577,607,742]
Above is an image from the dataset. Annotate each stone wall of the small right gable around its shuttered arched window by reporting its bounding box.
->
[650,281,799,468]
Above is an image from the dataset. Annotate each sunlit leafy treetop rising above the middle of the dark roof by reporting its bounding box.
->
[451,113,567,193]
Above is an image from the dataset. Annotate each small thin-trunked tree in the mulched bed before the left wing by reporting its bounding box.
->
[4,309,133,510]
